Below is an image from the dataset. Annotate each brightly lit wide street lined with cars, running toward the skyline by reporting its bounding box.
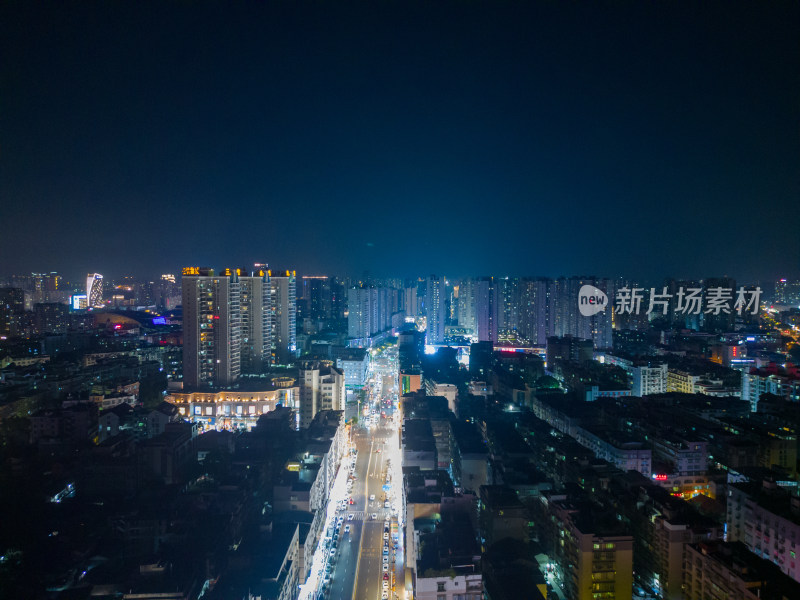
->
[300,349,405,600]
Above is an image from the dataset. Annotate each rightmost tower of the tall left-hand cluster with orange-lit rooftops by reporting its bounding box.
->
[267,270,297,365]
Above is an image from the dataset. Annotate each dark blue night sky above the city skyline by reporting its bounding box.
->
[0,1,800,278]
